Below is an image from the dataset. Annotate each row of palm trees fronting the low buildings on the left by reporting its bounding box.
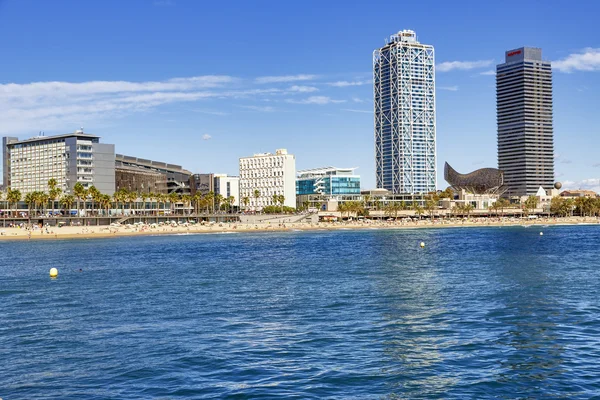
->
[0,179,235,216]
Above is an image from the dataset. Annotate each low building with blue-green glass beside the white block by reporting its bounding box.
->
[296,167,360,196]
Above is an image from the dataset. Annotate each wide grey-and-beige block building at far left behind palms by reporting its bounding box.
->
[2,129,115,195]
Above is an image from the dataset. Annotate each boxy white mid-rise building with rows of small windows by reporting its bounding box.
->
[240,149,296,210]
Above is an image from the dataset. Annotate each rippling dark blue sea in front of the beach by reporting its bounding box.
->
[0,226,600,400]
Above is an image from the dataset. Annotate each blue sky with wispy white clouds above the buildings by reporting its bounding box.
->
[0,0,600,191]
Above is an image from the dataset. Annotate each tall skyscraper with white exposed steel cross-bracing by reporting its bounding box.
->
[373,30,436,193]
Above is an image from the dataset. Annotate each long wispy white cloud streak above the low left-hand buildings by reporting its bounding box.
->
[0,75,298,135]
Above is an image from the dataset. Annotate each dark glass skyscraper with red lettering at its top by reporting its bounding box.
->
[496,47,554,196]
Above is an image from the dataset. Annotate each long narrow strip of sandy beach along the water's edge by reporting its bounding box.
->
[0,217,600,242]
